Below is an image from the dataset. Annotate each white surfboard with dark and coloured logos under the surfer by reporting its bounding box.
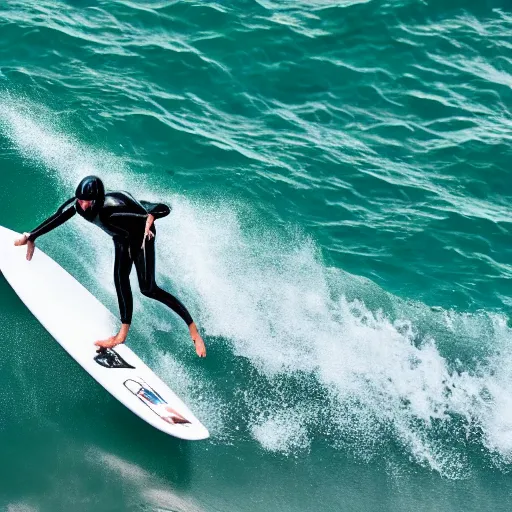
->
[0,226,209,440]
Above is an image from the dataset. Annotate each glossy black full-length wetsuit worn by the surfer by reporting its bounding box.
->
[28,192,193,325]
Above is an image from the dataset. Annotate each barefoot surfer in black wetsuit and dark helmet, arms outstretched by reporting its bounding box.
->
[14,176,206,357]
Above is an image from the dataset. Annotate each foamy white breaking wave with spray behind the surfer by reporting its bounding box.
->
[0,102,512,478]
